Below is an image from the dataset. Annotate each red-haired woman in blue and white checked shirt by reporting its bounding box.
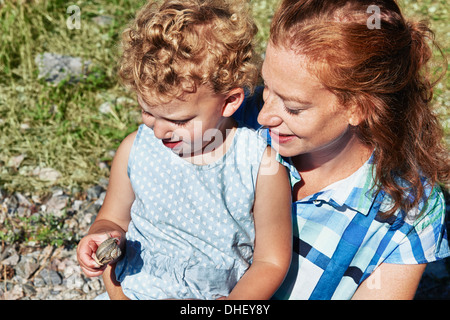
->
[240,0,450,299]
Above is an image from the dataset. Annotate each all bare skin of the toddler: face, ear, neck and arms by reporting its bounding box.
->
[77,86,292,300]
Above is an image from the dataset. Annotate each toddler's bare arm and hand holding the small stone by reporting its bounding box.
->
[77,132,136,298]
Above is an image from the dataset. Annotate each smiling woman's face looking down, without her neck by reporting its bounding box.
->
[258,44,354,157]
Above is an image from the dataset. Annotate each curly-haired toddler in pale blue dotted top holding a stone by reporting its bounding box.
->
[78,0,292,299]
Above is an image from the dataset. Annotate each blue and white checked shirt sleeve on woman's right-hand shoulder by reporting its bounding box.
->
[384,186,450,264]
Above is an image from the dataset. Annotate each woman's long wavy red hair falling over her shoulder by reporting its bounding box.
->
[270,0,450,214]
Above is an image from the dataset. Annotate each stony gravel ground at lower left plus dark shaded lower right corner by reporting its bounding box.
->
[0,185,450,300]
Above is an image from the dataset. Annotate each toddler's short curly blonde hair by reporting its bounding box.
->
[119,0,259,103]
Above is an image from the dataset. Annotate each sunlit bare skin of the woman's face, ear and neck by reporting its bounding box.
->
[258,44,372,199]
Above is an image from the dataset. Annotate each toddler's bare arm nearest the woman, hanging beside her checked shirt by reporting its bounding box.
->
[228,148,292,300]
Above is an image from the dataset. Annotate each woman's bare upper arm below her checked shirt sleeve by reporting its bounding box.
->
[352,263,427,300]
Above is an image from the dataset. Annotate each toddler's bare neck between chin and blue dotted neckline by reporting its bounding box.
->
[183,118,237,166]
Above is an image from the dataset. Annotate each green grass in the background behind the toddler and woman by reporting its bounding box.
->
[0,0,450,192]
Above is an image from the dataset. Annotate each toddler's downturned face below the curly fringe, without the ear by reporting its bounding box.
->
[138,86,226,157]
